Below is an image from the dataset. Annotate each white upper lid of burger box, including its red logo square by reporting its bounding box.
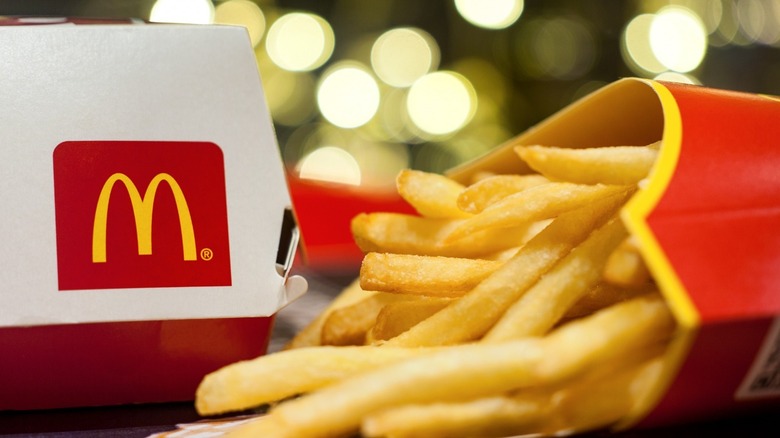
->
[0,24,306,326]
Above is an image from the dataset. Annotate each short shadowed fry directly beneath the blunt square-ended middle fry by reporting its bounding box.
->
[366,297,452,344]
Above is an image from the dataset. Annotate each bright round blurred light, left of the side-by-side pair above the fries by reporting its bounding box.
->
[317,63,380,128]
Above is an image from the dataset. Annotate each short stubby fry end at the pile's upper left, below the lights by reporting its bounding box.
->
[396,170,471,219]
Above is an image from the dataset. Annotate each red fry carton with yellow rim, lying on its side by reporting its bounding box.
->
[452,78,780,425]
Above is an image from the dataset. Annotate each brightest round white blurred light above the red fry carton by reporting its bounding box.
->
[650,6,707,73]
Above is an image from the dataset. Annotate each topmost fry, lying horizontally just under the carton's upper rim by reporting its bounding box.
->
[515,146,658,185]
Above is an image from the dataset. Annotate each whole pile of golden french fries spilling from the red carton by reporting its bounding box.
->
[196,144,675,437]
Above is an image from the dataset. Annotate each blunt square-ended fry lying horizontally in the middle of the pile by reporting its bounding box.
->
[360,253,502,297]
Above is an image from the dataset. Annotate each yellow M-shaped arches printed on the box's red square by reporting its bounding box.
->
[92,173,197,263]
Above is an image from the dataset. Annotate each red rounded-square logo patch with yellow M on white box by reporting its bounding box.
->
[53,141,231,290]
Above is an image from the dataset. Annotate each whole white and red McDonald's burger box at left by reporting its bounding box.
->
[0,23,307,410]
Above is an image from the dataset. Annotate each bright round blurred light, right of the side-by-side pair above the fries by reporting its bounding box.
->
[406,71,477,136]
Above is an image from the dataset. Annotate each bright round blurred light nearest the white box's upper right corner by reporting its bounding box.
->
[265,12,335,71]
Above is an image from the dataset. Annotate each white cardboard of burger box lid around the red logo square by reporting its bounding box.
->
[0,25,306,327]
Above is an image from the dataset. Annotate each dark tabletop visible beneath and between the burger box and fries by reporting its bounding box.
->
[0,273,780,438]
